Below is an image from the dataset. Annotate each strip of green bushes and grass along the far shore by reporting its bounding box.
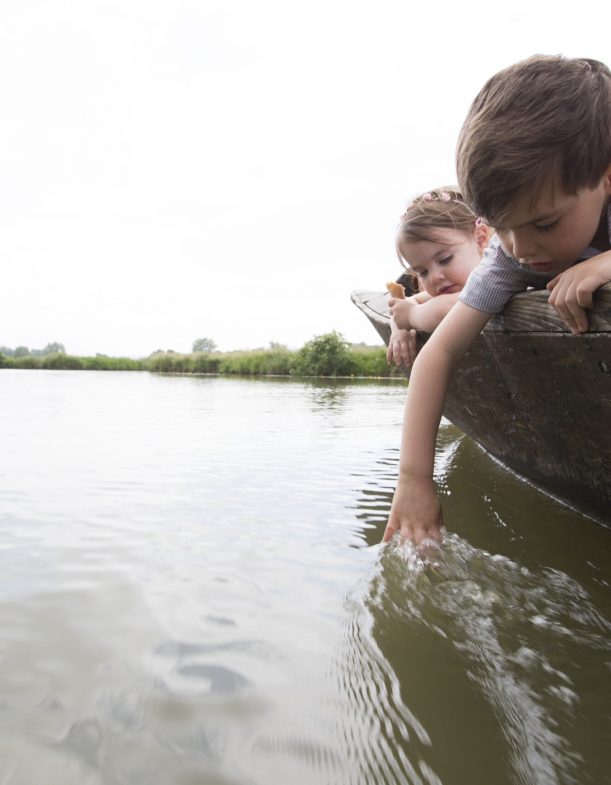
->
[0,332,405,379]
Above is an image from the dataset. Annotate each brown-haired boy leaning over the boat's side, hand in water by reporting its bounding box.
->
[384,55,611,543]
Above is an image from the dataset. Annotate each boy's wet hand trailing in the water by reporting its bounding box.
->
[382,477,443,545]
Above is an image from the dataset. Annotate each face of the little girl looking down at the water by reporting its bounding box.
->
[399,230,488,297]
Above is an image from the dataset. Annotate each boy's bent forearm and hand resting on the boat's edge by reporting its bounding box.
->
[547,251,611,333]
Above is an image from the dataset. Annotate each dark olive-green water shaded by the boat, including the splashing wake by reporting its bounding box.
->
[338,426,611,785]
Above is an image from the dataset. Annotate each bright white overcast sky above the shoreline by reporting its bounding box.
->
[0,0,611,357]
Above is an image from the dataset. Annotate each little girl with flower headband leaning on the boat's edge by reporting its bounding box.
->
[387,188,490,364]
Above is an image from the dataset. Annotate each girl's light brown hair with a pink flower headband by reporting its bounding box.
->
[396,186,480,290]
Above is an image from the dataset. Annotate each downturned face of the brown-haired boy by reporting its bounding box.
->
[496,173,611,275]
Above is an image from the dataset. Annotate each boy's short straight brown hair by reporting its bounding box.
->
[456,55,611,225]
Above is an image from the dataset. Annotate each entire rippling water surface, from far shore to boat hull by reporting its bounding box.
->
[0,370,611,785]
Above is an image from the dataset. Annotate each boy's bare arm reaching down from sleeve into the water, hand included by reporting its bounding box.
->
[384,301,491,544]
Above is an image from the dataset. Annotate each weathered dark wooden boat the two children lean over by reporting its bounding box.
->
[352,284,611,526]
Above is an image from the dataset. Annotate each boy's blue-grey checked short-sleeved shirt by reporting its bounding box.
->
[458,202,611,313]
